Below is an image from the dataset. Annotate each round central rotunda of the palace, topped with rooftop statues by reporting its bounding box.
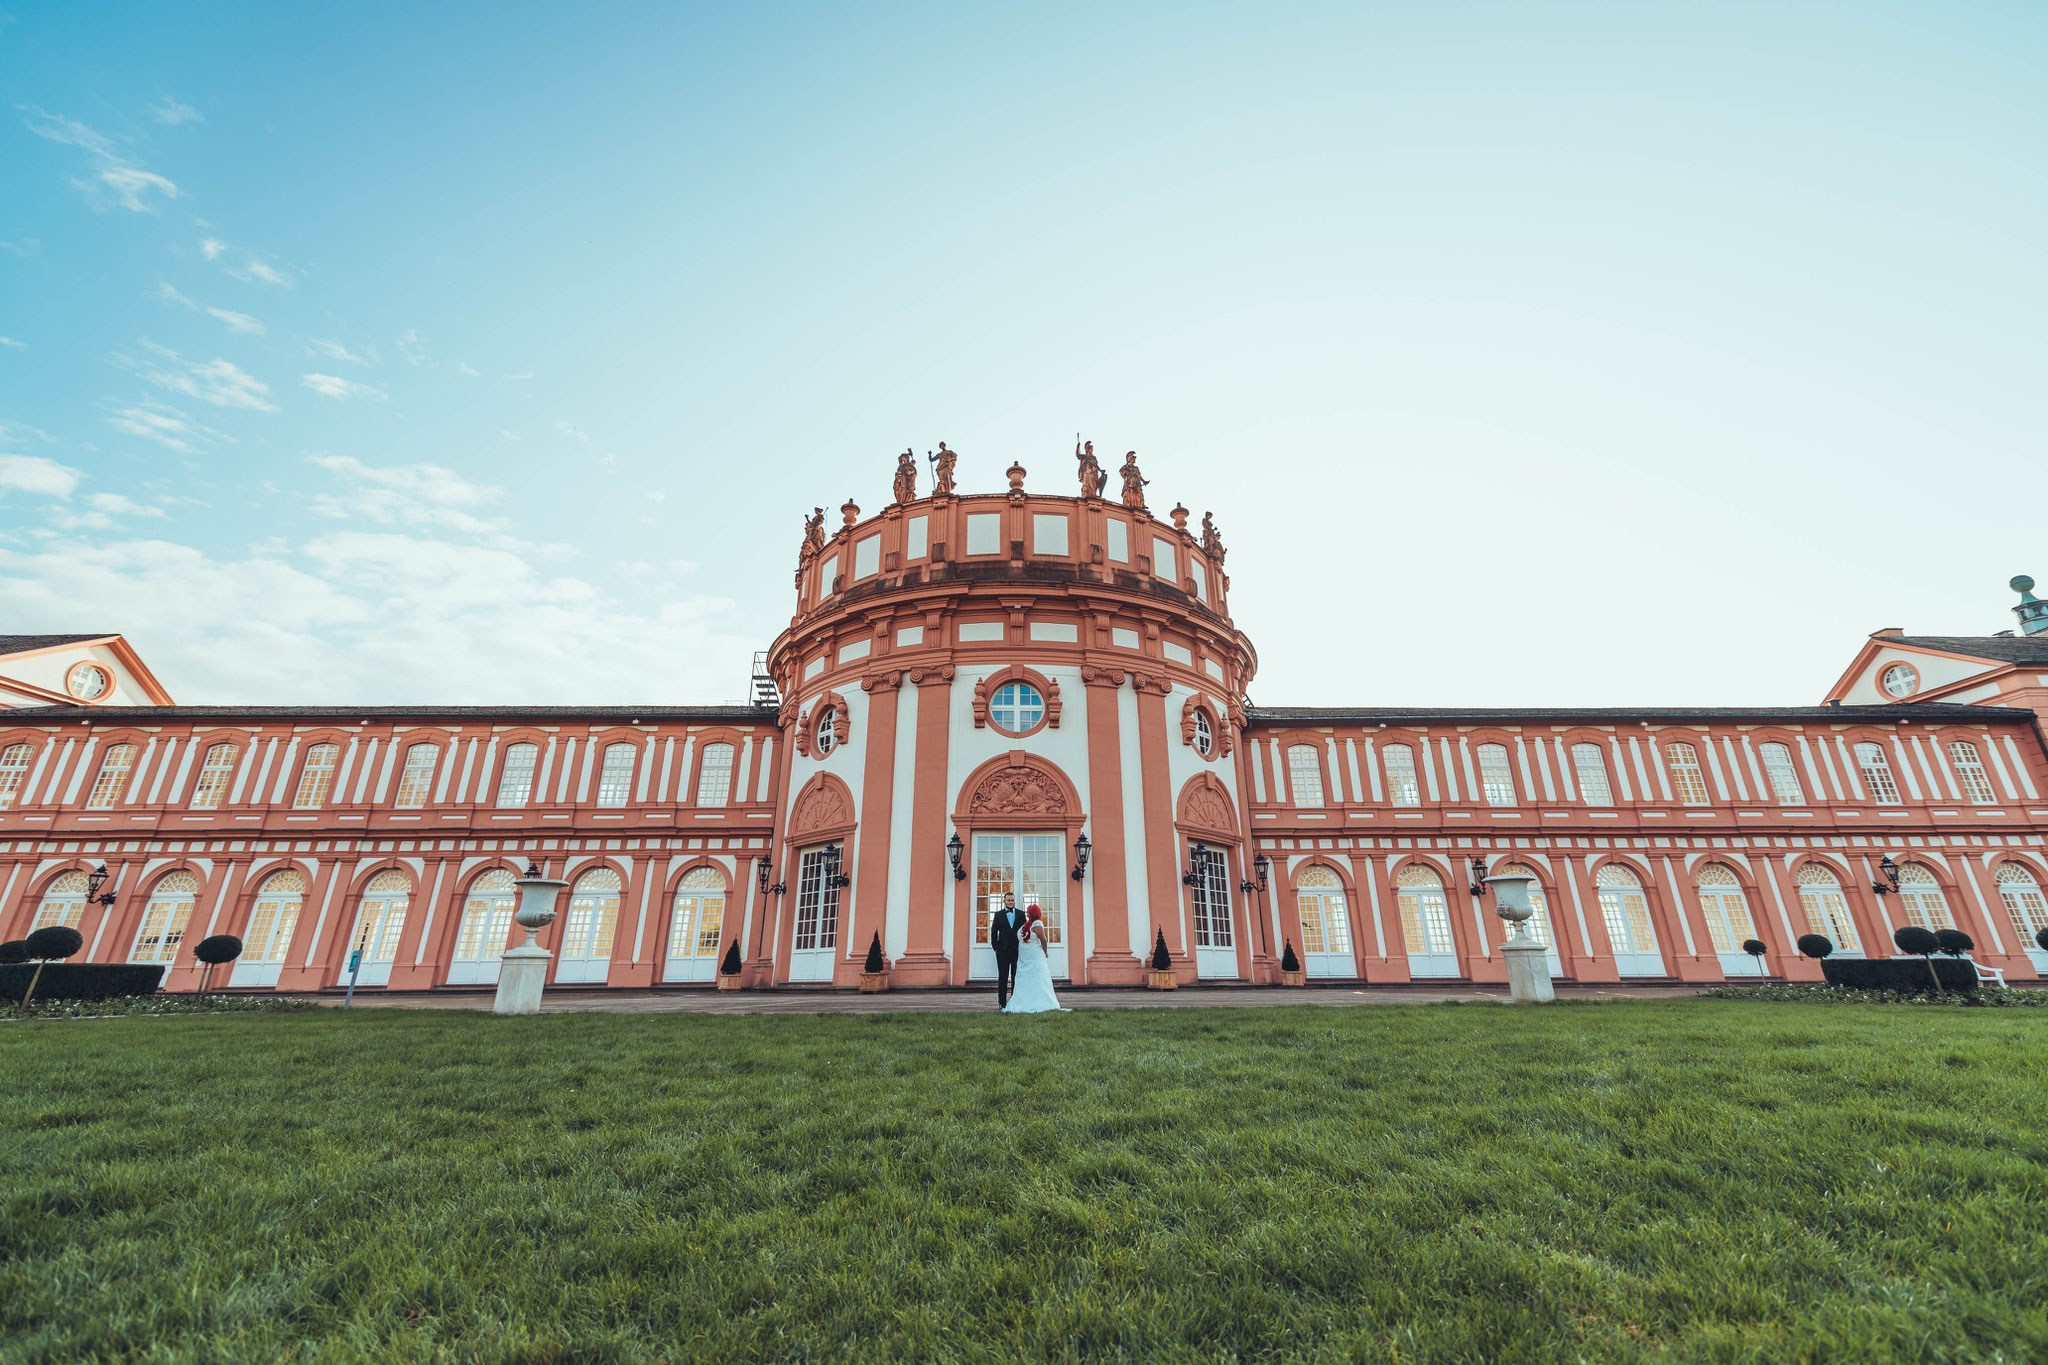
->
[758,442,1272,986]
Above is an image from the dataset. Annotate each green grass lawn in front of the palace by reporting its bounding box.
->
[0,1001,2048,1365]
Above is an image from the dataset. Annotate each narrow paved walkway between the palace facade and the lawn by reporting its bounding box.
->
[303,986,1700,1015]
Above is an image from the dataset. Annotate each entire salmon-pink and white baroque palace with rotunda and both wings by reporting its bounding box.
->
[0,446,2048,990]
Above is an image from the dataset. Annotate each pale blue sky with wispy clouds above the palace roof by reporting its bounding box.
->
[0,10,2048,706]
